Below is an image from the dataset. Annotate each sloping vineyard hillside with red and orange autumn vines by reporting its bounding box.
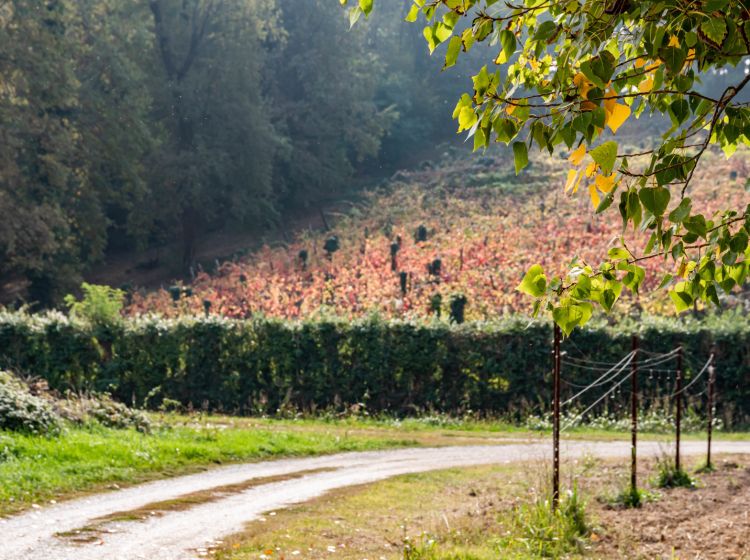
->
[128,145,750,319]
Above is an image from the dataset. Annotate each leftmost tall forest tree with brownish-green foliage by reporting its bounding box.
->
[0,0,90,303]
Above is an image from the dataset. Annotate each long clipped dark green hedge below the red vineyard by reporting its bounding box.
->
[0,313,750,424]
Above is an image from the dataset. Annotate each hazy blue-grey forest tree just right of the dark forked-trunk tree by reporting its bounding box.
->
[269,0,397,205]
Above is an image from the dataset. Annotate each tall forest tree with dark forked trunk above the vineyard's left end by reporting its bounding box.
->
[149,0,277,269]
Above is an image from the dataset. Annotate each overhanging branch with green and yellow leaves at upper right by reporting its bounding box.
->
[340,0,750,332]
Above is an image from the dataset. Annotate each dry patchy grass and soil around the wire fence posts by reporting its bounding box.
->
[211,456,750,560]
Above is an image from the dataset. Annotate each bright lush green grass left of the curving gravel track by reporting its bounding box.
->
[0,425,417,514]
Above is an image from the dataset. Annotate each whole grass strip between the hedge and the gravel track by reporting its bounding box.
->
[0,415,748,515]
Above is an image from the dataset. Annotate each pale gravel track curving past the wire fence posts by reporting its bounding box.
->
[0,441,750,560]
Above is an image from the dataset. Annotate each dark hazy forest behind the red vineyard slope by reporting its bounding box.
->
[0,0,478,306]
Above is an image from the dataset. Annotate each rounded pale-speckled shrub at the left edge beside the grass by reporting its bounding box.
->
[0,372,60,434]
